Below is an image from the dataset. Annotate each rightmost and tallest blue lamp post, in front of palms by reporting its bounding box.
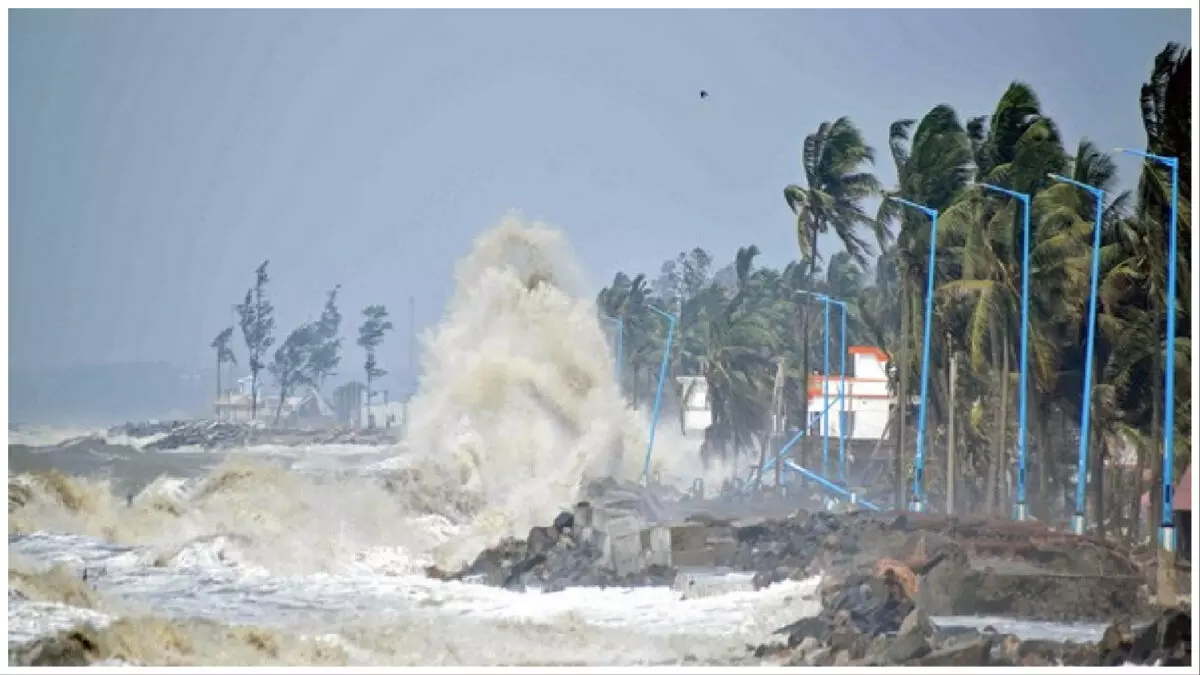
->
[1118,148,1180,552]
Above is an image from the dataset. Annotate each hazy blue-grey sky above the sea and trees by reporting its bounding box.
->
[8,10,1190,372]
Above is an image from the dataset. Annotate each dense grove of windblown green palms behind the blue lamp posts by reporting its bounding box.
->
[598,43,1192,537]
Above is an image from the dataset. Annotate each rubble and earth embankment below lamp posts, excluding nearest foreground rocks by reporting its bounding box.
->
[430,482,1152,621]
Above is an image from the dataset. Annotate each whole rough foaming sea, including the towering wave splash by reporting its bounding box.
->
[7,217,1103,667]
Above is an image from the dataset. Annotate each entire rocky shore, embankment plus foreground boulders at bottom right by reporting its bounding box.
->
[427,485,1192,668]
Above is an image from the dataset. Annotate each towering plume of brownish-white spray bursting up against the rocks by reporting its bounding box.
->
[404,217,646,566]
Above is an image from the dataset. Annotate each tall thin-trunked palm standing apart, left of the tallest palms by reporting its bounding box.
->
[784,117,888,473]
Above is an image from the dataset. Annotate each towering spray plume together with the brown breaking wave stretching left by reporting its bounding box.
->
[10,217,700,573]
